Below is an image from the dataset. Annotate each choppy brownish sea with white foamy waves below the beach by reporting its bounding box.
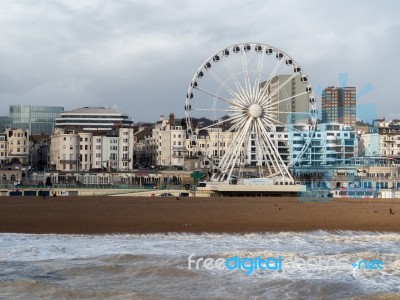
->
[0,231,400,299]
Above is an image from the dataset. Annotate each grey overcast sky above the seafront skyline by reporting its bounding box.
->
[0,0,400,122]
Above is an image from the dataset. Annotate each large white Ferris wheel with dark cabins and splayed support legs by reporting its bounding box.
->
[185,43,317,182]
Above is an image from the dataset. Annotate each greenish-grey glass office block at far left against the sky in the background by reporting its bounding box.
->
[0,105,64,135]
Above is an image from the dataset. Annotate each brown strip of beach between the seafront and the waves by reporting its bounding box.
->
[0,196,400,234]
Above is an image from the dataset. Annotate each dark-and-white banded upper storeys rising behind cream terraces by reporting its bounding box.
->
[55,107,133,132]
